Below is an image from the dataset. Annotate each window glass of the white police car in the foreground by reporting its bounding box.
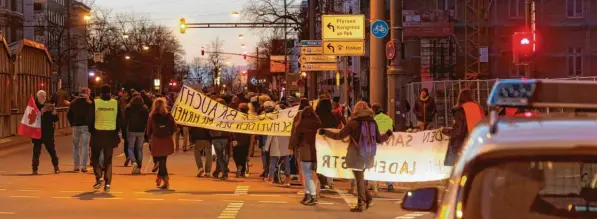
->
[464,160,597,219]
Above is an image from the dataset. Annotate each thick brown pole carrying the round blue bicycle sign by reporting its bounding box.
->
[369,0,386,109]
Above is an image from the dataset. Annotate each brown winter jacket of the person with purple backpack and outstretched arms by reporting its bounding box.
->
[325,109,388,170]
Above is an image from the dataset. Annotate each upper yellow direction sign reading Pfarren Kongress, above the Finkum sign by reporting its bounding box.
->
[321,15,365,40]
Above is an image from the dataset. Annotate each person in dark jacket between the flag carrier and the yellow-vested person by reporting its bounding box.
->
[67,88,91,173]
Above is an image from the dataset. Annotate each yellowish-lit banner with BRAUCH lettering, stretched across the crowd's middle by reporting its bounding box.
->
[171,86,298,136]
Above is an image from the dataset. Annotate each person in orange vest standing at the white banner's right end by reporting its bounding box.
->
[443,90,485,166]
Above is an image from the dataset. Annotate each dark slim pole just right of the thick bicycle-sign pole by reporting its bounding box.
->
[387,0,407,130]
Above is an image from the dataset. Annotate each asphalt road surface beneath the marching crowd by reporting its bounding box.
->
[0,133,432,219]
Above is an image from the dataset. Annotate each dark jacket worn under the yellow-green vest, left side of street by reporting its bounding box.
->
[87,94,124,148]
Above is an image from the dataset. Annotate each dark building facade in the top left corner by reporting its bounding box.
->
[0,0,24,43]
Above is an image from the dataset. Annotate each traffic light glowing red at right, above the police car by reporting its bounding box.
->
[512,32,535,65]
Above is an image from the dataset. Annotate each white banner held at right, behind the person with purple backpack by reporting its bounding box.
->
[316,129,452,182]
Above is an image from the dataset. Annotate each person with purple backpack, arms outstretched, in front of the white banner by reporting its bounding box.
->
[319,101,393,212]
